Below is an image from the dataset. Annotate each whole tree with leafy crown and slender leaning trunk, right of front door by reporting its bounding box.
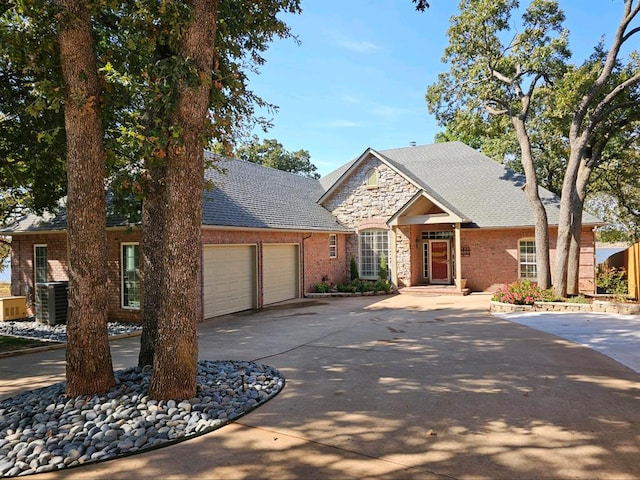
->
[427,0,569,288]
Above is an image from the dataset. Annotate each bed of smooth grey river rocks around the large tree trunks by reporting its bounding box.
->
[0,361,284,477]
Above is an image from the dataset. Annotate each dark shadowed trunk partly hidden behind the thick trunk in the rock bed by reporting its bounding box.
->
[138,160,167,367]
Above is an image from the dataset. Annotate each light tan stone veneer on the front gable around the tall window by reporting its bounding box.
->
[323,155,418,278]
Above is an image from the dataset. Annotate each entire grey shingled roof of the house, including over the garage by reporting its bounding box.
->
[0,142,603,234]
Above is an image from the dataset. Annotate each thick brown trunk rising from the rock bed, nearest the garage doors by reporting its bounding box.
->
[149,0,217,399]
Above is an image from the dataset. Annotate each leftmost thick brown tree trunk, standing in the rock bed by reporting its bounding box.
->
[59,0,115,397]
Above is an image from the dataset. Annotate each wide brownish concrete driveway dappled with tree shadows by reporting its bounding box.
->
[0,294,640,479]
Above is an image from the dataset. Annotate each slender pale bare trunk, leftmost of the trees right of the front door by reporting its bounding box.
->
[511,117,551,289]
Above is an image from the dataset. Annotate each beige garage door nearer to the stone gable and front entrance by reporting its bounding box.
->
[262,245,299,305]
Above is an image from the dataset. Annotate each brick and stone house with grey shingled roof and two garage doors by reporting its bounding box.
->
[3,142,600,320]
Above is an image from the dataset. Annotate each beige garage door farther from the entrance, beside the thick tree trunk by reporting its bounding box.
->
[202,245,256,318]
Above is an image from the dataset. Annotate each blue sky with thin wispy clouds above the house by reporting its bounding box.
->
[251,0,623,175]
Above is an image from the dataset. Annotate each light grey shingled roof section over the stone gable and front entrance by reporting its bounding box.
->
[322,142,603,228]
